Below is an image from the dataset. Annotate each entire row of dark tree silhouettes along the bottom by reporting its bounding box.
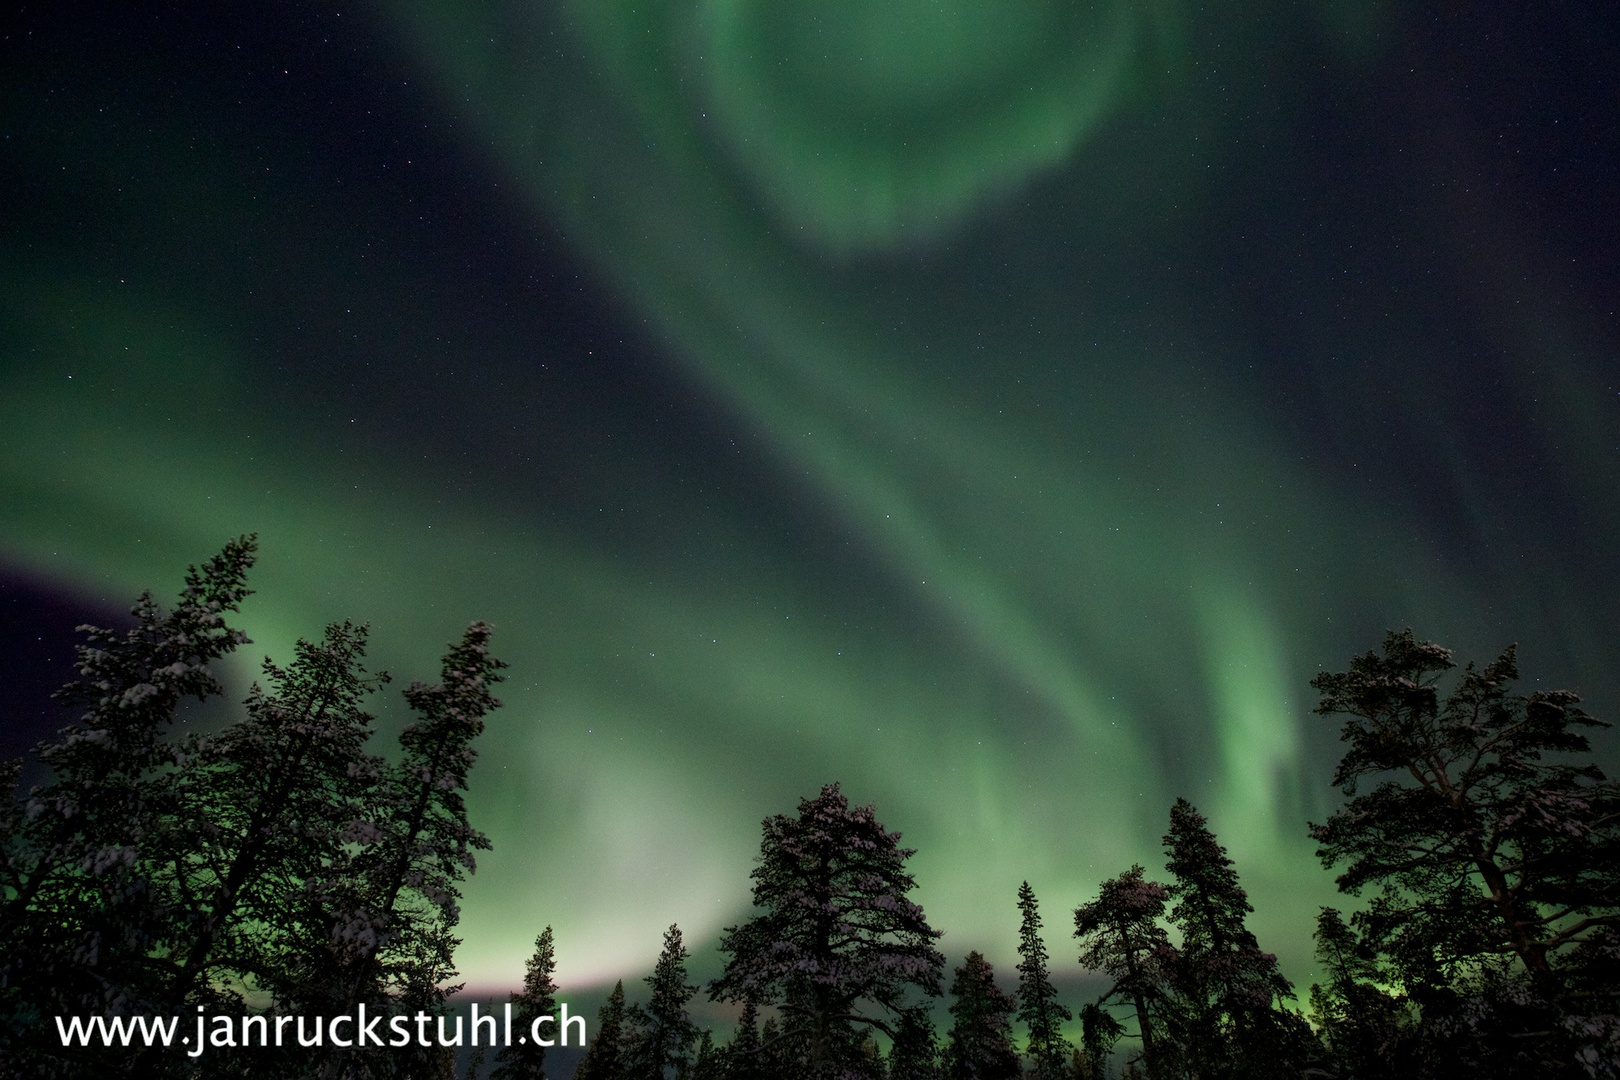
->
[0,538,1620,1080]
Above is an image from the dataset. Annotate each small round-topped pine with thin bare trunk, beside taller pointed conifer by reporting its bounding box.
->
[1074,866,1176,1080]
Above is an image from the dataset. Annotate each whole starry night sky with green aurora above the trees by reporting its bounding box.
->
[0,0,1620,988]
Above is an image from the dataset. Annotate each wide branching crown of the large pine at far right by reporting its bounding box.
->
[1311,630,1620,996]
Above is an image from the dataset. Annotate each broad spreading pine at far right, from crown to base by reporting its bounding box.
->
[1311,630,1620,1077]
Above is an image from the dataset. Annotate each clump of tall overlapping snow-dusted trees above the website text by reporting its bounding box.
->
[0,538,502,1080]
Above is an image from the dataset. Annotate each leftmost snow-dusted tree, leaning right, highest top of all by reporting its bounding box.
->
[0,536,256,1075]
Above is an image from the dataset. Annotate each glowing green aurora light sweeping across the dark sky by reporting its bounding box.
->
[0,0,1614,1003]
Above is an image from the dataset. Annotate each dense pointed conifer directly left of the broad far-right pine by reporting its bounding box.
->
[1165,798,1311,1080]
